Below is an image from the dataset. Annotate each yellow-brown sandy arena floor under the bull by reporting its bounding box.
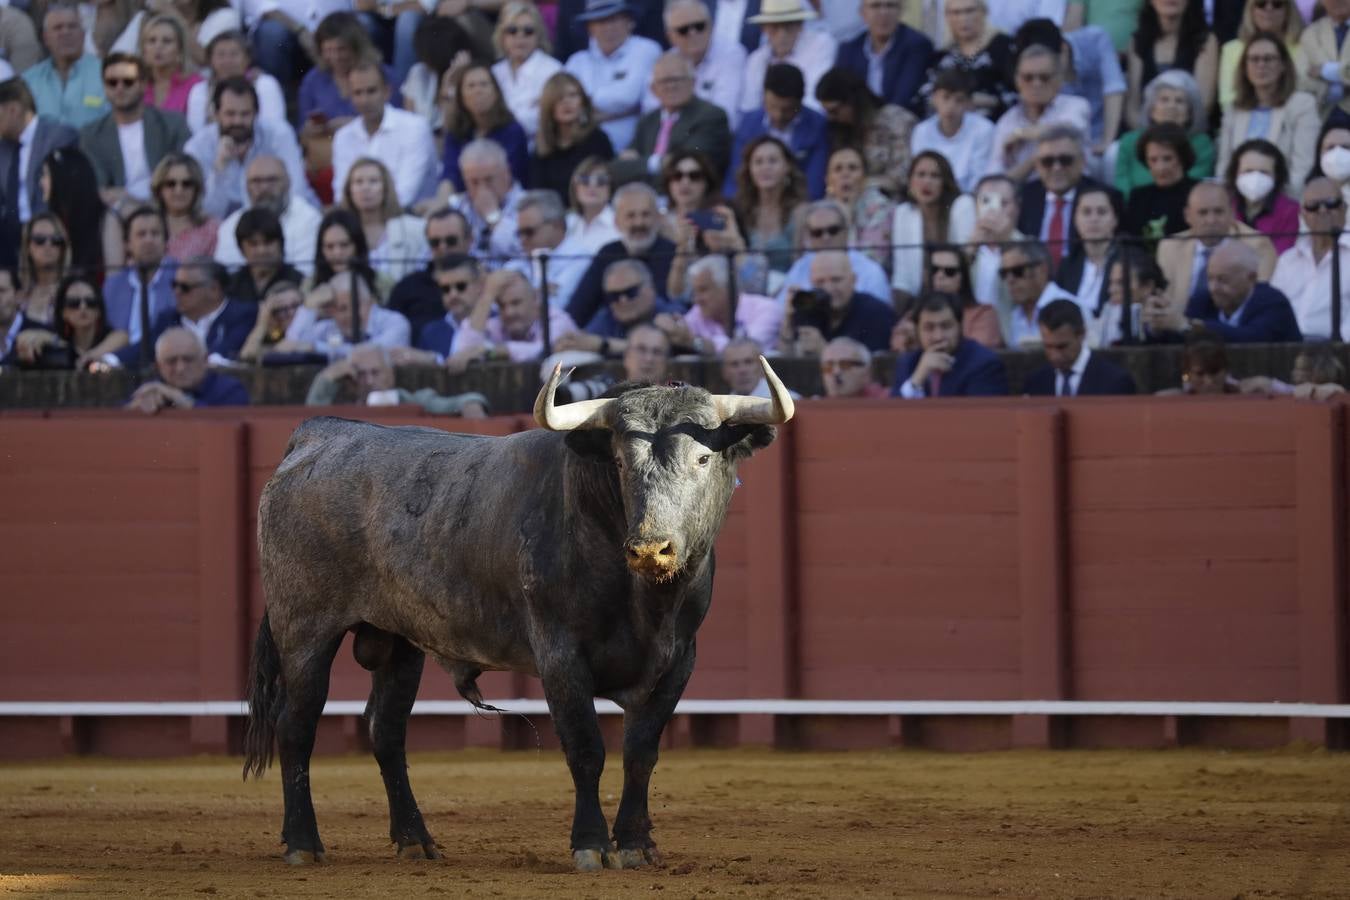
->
[0,750,1350,900]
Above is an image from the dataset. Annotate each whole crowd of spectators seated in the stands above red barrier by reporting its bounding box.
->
[0,0,1350,416]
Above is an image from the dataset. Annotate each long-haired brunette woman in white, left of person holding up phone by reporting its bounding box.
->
[887,150,975,296]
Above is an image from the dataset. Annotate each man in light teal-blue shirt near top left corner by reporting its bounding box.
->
[23,0,108,130]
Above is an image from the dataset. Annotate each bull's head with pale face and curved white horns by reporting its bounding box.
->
[535,356,794,582]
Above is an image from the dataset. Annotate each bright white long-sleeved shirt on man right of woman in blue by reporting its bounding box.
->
[333,104,439,206]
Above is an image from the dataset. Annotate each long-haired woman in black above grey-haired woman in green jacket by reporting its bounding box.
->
[1125,0,1219,128]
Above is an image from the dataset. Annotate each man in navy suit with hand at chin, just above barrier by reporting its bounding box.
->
[891,294,1008,399]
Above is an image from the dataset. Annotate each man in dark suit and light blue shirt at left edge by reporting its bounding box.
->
[0,78,77,266]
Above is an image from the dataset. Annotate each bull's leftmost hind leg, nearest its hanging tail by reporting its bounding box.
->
[277,633,343,865]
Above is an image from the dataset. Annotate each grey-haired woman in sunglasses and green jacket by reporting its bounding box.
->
[1114,69,1214,198]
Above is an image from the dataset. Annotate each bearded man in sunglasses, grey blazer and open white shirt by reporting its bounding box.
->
[80,53,192,206]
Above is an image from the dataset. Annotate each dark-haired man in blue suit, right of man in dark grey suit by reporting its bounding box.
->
[722,62,830,200]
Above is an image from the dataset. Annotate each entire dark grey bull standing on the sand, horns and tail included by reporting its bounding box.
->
[244,359,792,869]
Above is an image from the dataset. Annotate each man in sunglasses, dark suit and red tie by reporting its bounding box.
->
[1017,125,1125,271]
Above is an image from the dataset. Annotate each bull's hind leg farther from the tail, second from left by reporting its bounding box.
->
[358,626,440,860]
